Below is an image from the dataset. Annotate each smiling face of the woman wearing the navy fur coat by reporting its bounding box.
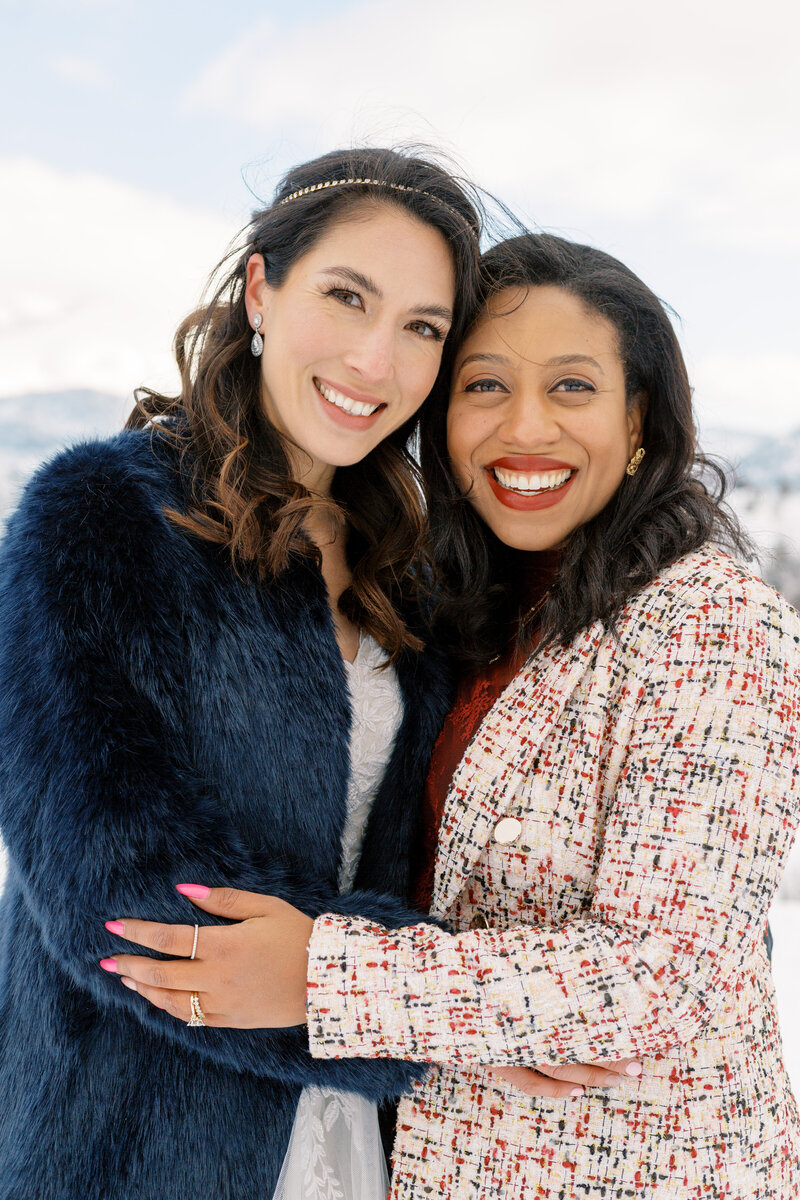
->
[246,204,456,492]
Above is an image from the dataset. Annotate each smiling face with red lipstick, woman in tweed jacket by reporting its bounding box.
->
[447,287,642,551]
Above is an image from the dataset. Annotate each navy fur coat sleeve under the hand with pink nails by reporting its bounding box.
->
[0,446,431,1098]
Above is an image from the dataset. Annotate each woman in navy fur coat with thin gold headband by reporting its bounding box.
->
[0,150,480,1200]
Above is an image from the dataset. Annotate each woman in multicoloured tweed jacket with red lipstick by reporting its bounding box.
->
[103,235,800,1200]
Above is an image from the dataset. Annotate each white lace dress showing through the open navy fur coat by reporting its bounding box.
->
[272,634,403,1200]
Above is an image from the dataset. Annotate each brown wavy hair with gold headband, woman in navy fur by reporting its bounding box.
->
[127,148,481,659]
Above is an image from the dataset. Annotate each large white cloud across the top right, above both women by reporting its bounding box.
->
[184,0,800,248]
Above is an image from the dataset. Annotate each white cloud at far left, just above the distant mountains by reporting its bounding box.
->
[0,158,235,396]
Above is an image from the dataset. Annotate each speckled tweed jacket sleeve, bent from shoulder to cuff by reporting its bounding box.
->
[308,561,800,1064]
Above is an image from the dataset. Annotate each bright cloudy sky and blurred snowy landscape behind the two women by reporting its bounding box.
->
[0,0,800,1087]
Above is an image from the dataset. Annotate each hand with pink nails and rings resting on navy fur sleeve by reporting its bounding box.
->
[101,883,314,1030]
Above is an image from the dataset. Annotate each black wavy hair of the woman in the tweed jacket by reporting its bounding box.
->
[420,233,752,665]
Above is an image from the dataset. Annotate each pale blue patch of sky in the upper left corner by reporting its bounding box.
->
[0,0,296,209]
